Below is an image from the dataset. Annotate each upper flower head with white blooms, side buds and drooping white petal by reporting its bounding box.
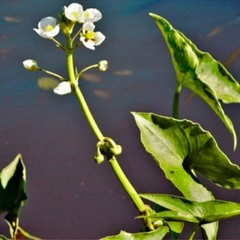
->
[23,3,108,95]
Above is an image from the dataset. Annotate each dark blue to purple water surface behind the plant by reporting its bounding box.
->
[0,0,240,239]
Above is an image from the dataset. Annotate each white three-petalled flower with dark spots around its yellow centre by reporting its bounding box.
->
[80,22,106,50]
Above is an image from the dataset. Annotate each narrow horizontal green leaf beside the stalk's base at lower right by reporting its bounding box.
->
[139,194,240,224]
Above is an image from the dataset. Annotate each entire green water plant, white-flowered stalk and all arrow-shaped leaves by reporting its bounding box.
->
[0,3,240,240]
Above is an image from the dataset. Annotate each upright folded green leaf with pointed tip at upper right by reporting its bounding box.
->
[150,13,240,149]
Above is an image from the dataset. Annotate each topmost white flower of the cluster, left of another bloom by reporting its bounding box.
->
[64,3,84,23]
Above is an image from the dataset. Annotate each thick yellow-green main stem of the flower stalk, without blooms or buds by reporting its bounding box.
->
[64,37,147,218]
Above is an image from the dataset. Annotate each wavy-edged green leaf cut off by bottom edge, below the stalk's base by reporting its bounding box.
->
[101,226,169,240]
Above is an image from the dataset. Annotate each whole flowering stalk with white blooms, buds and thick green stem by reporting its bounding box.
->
[23,3,150,230]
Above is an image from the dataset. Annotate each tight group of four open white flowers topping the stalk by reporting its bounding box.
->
[33,3,106,50]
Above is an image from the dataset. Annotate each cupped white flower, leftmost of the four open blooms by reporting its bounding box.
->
[33,17,60,38]
